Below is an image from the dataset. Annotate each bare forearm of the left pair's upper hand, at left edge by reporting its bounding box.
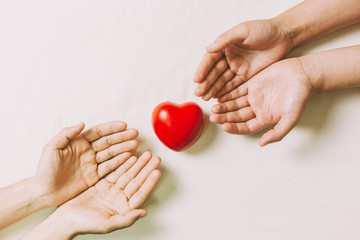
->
[0,178,47,229]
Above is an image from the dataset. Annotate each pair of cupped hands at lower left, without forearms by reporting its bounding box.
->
[30,122,160,236]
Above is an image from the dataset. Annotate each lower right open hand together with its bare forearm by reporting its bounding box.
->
[210,45,360,146]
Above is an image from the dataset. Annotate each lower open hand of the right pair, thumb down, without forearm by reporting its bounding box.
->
[210,58,313,146]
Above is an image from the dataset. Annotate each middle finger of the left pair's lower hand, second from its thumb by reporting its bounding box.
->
[124,156,161,199]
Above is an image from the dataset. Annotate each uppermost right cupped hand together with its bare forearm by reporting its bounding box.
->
[194,0,360,101]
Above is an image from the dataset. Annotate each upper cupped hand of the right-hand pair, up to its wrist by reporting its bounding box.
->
[194,20,292,101]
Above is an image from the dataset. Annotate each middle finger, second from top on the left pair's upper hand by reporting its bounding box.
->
[91,129,139,152]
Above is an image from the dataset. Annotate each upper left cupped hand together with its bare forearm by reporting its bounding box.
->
[0,121,138,229]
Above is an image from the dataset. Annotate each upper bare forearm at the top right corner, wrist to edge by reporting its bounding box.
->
[273,0,360,47]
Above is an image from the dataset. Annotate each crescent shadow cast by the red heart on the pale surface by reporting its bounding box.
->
[185,114,219,155]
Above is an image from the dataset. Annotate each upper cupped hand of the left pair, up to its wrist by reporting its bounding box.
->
[35,121,138,206]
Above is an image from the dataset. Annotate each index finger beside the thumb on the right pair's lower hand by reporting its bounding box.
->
[221,118,267,135]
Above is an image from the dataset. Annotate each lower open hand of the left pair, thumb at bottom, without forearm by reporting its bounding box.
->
[54,152,161,235]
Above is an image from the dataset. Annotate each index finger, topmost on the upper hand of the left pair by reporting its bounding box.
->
[83,121,127,142]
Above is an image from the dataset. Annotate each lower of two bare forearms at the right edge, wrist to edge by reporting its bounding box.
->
[299,45,360,92]
